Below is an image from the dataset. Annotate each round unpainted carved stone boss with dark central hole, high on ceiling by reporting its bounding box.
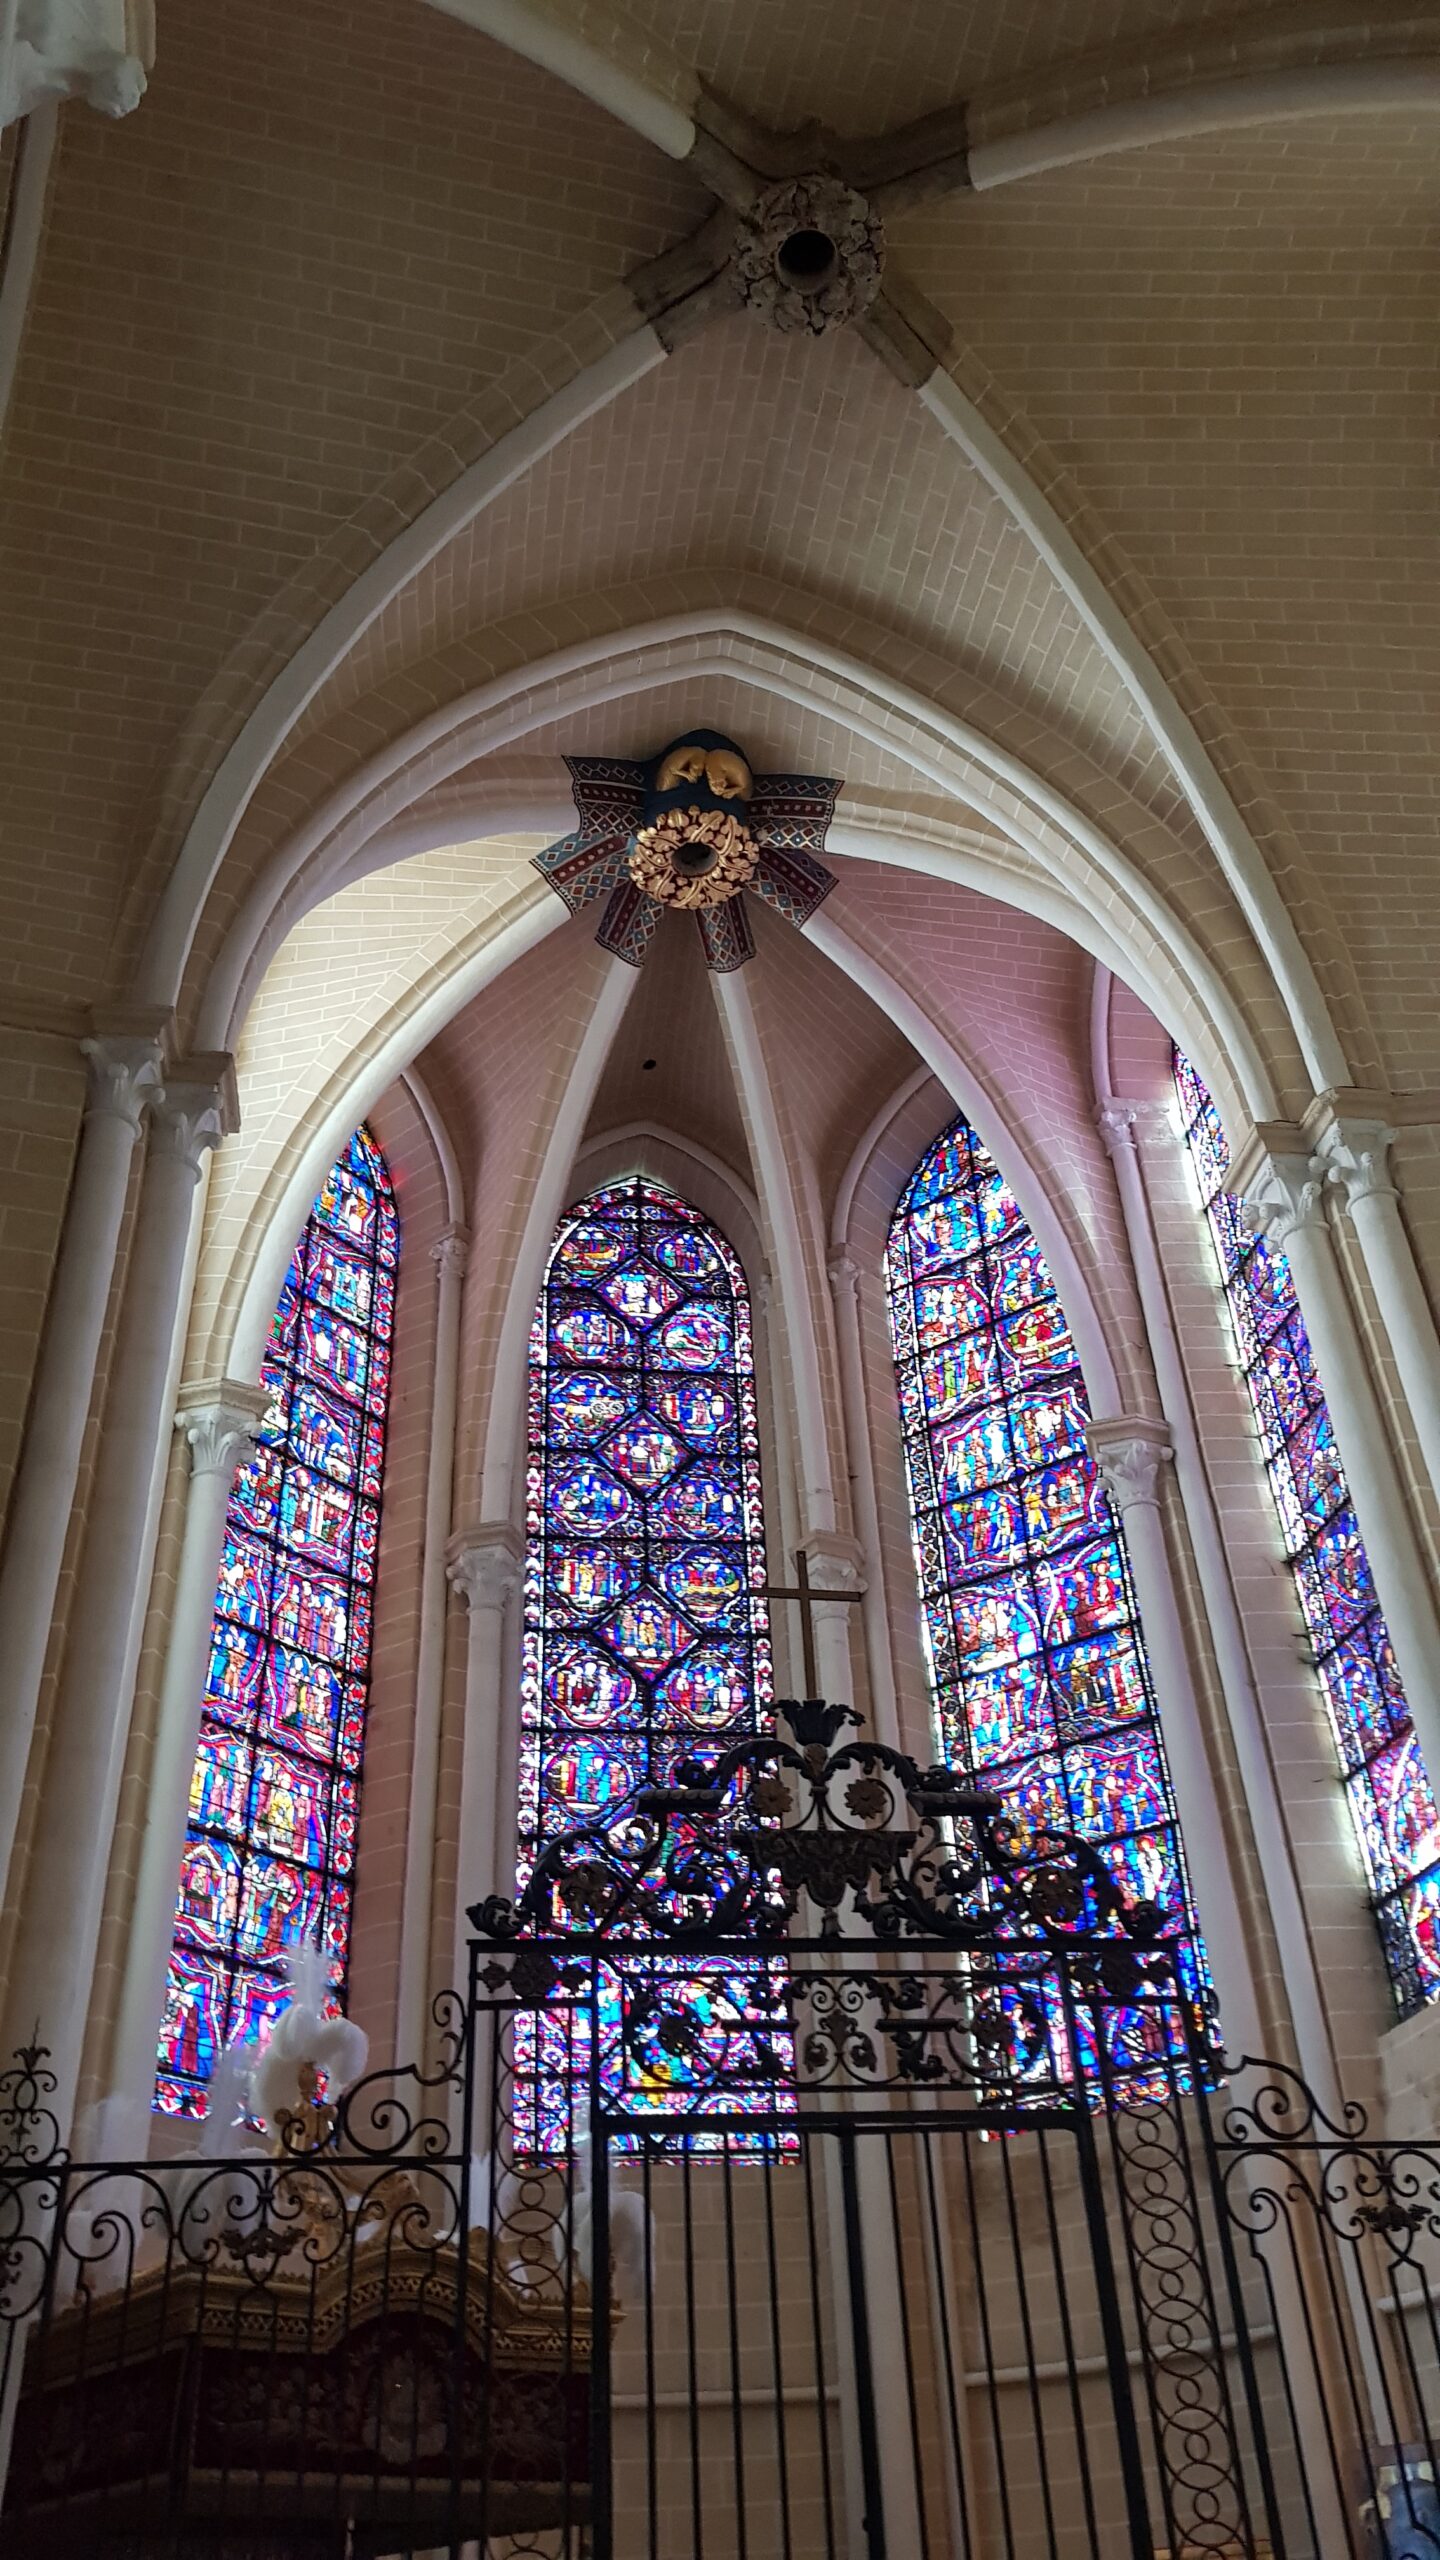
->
[730,172,884,338]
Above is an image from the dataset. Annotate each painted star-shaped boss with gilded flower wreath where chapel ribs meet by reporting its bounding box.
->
[536,730,840,970]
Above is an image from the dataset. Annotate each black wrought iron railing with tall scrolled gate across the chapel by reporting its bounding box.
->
[0,1702,1440,2560]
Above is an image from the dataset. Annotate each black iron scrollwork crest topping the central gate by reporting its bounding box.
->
[469,1697,1194,1999]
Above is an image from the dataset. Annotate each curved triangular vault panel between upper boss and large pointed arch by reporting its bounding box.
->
[292,315,1176,817]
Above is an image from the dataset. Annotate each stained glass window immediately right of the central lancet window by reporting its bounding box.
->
[887,1119,1204,2058]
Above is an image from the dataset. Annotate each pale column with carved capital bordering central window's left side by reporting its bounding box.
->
[446,1521,525,1987]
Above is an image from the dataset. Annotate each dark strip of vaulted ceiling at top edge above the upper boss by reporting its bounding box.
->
[625,0,1235,133]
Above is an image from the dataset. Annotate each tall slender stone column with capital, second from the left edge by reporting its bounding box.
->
[0,1057,233,2127]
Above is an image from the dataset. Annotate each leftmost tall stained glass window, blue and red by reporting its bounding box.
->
[156,1129,400,2115]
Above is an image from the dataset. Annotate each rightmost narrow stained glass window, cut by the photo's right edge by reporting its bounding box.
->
[1174,1050,1440,2015]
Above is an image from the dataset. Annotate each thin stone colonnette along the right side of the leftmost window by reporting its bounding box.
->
[395,1226,469,2063]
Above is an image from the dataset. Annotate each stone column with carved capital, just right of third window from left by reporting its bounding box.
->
[1086,1416,1266,2053]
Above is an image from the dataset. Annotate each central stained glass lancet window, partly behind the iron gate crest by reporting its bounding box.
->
[518,1178,774,2148]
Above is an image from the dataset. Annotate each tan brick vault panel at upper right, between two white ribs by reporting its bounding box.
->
[897,113,1440,1083]
